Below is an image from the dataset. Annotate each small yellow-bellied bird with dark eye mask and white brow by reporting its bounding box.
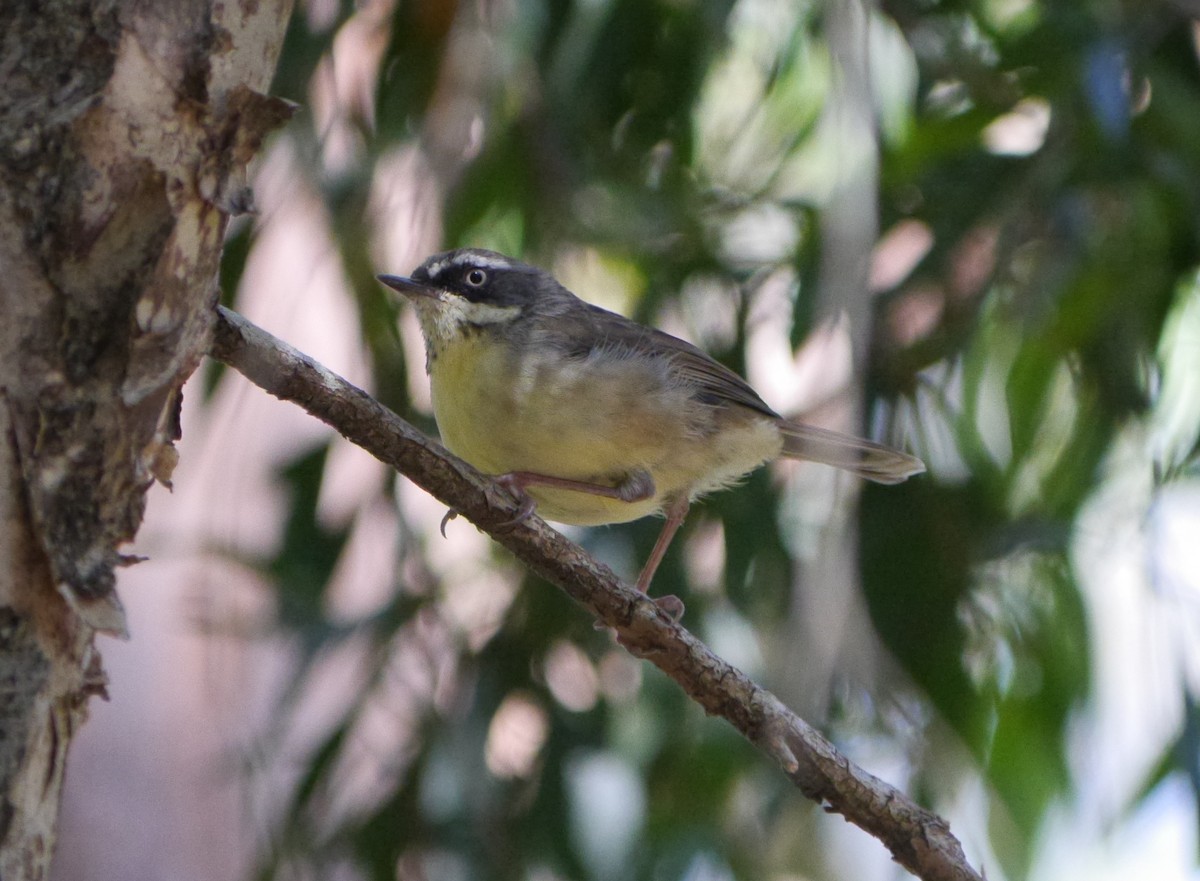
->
[378,248,925,617]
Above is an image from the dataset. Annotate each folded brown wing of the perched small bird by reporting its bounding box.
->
[556,304,779,419]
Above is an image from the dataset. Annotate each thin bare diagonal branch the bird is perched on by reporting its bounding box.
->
[211,307,983,881]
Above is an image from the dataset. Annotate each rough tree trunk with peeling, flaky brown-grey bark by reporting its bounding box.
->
[0,0,292,881]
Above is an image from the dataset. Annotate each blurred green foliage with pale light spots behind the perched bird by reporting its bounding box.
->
[214,0,1200,880]
